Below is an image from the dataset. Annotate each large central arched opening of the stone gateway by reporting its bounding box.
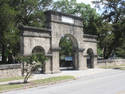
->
[59,35,78,70]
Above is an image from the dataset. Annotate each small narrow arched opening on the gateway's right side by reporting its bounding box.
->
[87,48,94,68]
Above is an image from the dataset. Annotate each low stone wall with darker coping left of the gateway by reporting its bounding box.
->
[0,64,21,78]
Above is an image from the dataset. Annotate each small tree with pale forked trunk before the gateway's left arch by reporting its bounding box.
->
[17,53,47,83]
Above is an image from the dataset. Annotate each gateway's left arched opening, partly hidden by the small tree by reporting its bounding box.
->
[32,46,45,73]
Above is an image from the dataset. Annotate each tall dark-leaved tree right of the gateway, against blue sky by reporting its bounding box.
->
[94,0,125,58]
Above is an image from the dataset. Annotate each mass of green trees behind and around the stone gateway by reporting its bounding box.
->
[0,0,125,63]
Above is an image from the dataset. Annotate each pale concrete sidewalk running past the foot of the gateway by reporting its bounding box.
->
[0,68,111,85]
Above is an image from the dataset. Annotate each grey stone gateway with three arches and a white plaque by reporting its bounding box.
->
[20,11,97,73]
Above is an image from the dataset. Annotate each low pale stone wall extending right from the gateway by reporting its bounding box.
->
[97,59,125,67]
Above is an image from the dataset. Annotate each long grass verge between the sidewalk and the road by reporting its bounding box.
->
[0,76,75,92]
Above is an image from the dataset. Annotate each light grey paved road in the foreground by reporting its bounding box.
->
[4,70,125,94]
